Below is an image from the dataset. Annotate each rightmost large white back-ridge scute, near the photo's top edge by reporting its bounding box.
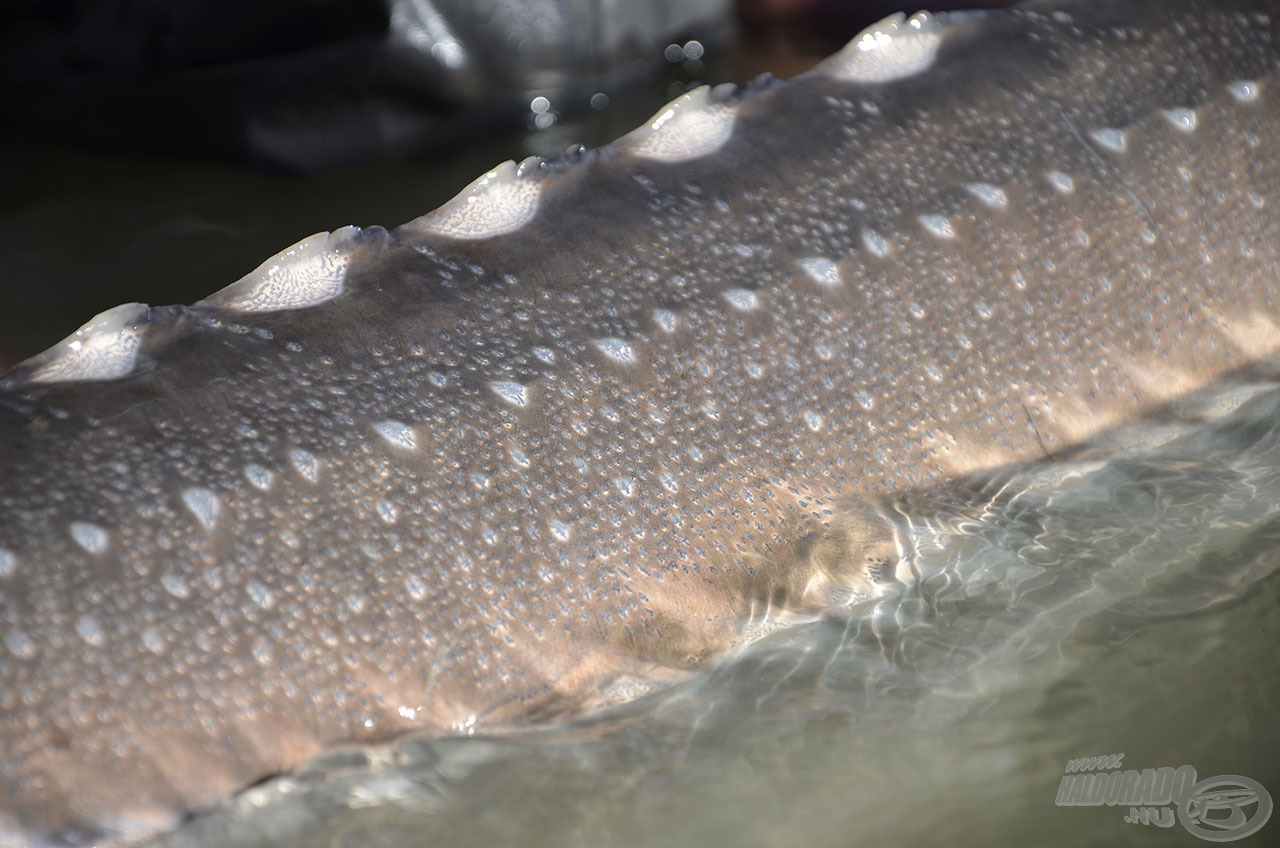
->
[818,12,945,83]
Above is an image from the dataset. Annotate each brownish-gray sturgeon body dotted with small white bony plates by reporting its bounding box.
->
[0,0,1280,844]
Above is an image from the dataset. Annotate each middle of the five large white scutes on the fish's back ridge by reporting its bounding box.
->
[407,160,541,241]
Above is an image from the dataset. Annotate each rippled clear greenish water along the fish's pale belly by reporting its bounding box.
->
[140,383,1280,847]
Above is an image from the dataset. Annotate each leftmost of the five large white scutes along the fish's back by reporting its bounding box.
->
[18,304,148,383]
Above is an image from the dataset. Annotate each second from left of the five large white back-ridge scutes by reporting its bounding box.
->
[205,227,360,313]
